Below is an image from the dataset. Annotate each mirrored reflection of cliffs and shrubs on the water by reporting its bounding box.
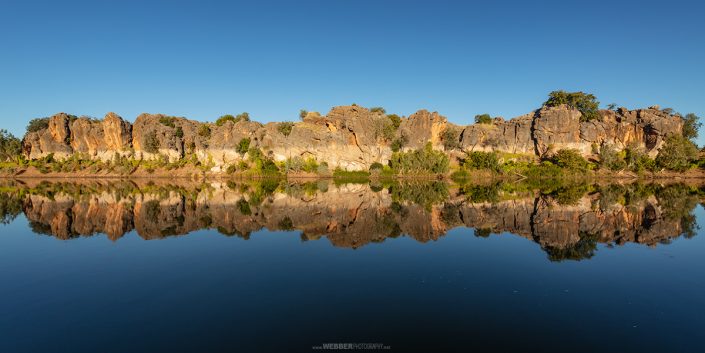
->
[0,180,705,261]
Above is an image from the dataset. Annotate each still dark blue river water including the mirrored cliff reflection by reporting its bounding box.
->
[0,180,705,352]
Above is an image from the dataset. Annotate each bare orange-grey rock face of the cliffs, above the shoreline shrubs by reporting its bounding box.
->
[23,105,683,172]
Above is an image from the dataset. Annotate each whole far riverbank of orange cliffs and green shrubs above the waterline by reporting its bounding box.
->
[0,91,705,180]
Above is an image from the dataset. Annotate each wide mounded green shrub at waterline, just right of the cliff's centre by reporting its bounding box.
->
[390,142,450,174]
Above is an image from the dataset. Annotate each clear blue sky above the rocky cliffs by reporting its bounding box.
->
[0,0,705,144]
